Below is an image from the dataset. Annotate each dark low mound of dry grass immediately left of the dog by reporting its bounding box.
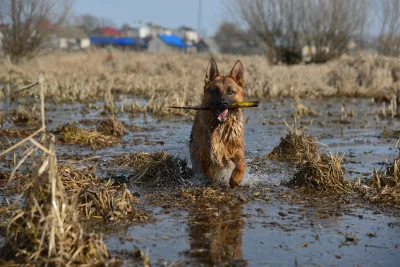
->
[114,151,192,187]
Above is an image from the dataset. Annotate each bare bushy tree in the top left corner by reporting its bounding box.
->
[0,0,73,62]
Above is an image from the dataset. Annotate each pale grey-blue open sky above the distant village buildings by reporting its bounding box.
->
[73,0,227,36]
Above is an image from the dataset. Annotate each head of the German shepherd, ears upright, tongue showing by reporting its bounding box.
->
[203,58,244,123]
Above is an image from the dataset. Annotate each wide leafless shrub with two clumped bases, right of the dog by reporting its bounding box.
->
[228,0,368,63]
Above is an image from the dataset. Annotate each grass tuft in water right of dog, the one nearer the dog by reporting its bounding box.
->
[267,124,320,163]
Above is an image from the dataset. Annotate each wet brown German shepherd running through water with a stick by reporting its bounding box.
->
[189,59,246,188]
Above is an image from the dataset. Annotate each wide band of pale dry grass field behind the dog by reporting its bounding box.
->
[0,49,400,115]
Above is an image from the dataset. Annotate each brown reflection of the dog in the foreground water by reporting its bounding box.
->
[189,205,246,266]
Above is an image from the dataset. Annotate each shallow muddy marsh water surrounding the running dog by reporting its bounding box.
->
[0,96,400,266]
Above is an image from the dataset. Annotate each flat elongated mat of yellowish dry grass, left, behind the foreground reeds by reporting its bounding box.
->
[54,124,119,149]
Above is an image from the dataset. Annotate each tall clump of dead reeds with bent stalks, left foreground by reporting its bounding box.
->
[0,73,110,266]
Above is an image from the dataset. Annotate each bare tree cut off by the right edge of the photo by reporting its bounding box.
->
[374,0,400,56]
